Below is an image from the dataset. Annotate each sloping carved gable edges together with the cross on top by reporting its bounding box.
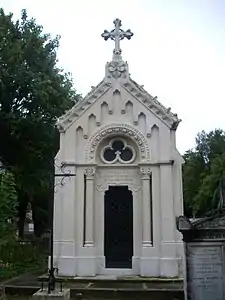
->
[57,19,181,132]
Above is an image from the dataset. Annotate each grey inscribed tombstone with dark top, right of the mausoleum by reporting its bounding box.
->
[177,207,225,300]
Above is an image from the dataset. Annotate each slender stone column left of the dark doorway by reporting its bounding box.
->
[84,167,95,247]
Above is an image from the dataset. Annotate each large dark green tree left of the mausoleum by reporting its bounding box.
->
[0,9,78,235]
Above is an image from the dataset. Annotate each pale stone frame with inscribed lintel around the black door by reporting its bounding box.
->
[94,166,142,274]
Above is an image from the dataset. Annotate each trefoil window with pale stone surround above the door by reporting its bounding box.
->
[101,139,135,164]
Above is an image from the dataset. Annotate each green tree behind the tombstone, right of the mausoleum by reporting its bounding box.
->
[183,129,225,216]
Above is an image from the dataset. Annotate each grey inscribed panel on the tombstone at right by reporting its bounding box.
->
[186,242,225,300]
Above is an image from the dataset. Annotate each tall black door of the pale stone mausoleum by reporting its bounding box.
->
[104,186,133,269]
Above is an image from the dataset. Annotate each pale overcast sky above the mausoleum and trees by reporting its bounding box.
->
[0,0,225,153]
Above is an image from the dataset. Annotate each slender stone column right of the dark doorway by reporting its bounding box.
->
[141,167,152,247]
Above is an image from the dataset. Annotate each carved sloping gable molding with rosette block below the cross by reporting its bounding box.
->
[56,72,181,132]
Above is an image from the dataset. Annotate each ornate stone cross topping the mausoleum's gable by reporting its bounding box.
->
[102,19,134,60]
